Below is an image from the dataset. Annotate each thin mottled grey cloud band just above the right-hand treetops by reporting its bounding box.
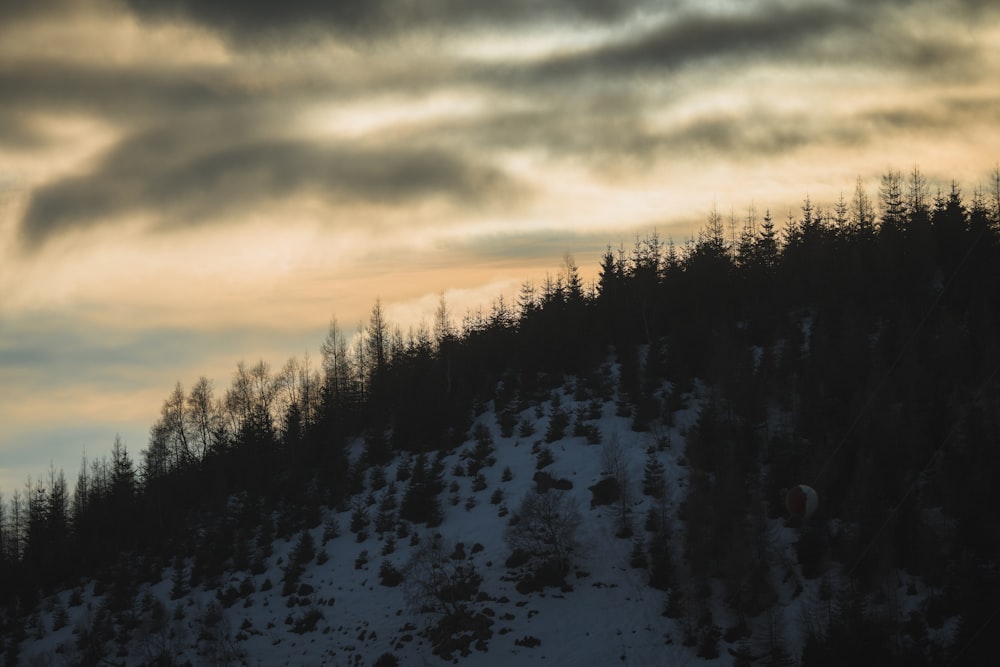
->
[419,88,1000,175]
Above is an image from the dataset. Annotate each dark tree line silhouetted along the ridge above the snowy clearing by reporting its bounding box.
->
[0,168,1000,655]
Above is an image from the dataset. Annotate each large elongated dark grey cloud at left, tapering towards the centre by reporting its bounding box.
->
[21,120,525,246]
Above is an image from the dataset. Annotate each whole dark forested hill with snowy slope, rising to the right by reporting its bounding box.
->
[0,170,1000,665]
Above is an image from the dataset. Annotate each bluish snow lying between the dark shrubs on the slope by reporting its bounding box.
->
[13,374,852,667]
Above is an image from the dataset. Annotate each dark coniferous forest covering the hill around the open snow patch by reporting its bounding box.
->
[0,168,1000,665]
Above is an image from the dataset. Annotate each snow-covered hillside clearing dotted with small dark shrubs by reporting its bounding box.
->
[15,374,848,667]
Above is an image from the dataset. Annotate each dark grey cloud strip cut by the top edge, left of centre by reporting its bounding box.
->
[127,0,646,44]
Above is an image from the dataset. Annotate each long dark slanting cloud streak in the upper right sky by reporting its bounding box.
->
[481,0,982,91]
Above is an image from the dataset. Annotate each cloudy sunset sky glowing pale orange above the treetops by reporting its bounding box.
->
[0,0,1000,497]
